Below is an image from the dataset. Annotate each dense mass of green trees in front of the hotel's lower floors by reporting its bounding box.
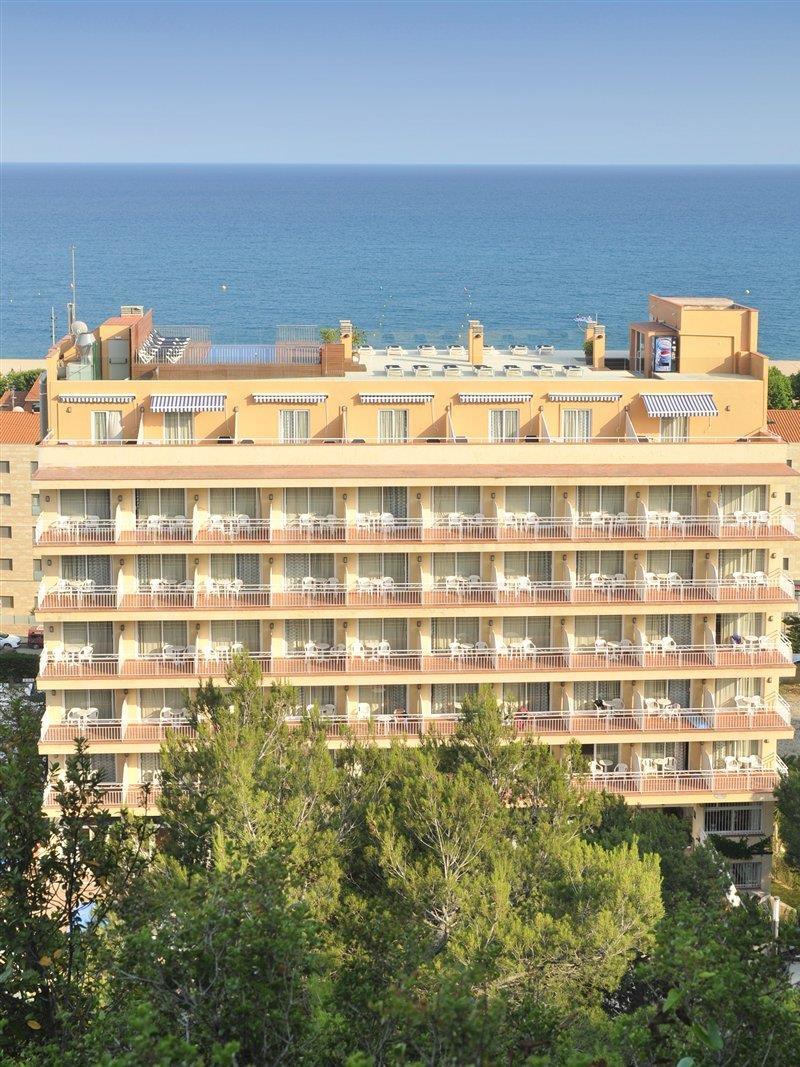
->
[0,660,800,1067]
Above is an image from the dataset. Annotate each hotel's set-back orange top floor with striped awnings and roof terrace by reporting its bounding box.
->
[36,296,779,460]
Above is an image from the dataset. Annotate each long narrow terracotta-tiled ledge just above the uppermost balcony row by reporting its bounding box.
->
[34,463,800,485]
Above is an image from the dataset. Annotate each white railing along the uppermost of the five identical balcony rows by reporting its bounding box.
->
[36,510,797,545]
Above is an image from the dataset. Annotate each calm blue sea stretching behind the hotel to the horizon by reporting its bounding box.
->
[0,164,800,357]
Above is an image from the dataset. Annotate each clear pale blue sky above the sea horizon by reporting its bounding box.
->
[2,0,800,163]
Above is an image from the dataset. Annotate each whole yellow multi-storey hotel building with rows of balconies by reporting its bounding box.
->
[35,296,796,888]
